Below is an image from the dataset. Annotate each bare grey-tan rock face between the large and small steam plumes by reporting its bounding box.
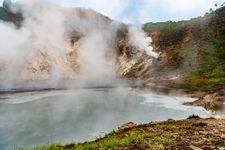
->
[116,26,155,80]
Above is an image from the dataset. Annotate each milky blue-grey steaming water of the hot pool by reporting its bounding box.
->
[0,88,210,150]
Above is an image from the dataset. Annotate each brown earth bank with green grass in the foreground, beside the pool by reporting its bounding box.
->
[49,116,225,150]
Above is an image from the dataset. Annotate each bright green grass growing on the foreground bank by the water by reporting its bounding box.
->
[18,124,181,150]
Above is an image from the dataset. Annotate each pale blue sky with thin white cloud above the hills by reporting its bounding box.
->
[0,0,225,24]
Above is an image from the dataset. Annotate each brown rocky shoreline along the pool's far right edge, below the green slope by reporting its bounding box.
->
[135,80,225,116]
